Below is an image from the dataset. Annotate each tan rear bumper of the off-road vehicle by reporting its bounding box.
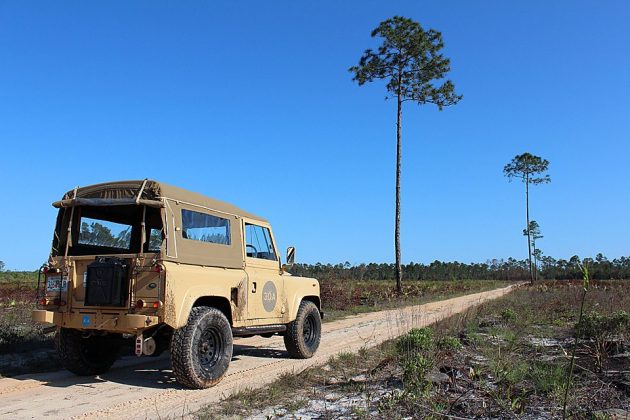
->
[33,309,160,332]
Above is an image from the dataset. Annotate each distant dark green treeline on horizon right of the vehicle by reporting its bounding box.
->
[290,254,630,281]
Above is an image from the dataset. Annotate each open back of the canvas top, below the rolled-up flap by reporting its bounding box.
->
[53,205,164,256]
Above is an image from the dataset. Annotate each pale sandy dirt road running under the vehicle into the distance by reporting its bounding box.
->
[0,286,513,419]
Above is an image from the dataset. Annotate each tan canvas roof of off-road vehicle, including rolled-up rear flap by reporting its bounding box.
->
[53,179,267,223]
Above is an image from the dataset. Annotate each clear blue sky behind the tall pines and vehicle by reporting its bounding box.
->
[0,0,630,269]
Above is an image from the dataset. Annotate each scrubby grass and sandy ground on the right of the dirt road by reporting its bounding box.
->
[198,281,630,418]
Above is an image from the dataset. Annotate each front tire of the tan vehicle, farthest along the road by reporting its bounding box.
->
[284,300,322,359]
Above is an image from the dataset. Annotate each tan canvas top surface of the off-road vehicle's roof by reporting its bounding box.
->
[58,179,267,223]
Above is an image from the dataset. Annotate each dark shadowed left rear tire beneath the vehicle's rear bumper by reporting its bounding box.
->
[55,328,122,376]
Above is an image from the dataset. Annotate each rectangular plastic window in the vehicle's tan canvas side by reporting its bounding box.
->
[182,210,230,245]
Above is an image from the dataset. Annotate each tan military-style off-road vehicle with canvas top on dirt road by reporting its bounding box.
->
[33,180,323,388]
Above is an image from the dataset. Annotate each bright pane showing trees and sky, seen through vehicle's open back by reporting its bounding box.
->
[78,217,131,250]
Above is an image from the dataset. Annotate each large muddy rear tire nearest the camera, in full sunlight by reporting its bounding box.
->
[171,306,232,389]
